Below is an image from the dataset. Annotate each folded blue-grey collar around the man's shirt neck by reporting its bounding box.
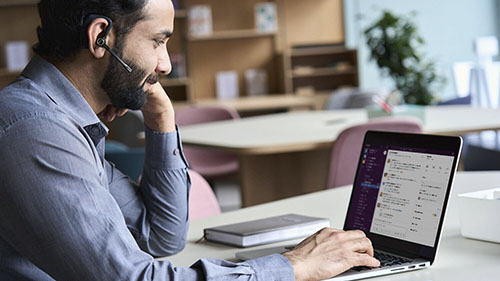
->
[21,54,108,130]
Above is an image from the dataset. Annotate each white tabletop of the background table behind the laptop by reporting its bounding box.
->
[181,106,500,154]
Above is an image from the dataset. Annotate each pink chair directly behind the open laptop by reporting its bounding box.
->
[326,117,422,188]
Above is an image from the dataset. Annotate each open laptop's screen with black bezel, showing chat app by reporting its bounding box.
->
[344,132,460,262]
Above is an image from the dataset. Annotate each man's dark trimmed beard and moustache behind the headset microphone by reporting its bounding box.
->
[101,40,159,110]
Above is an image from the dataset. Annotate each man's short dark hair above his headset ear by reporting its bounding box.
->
[33,0,148,61]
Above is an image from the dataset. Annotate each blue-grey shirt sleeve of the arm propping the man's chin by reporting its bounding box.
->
[105,124,190,257]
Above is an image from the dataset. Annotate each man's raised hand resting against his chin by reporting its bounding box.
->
[141,82,175,133]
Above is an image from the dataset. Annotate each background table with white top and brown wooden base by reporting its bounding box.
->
[181,106,500,206]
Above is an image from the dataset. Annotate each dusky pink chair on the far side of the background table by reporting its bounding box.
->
[175,105,240,180]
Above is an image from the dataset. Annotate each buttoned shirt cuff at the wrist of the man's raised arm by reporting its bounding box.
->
[144,126,189,169]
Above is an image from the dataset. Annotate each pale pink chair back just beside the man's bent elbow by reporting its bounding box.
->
[189,170,221,221]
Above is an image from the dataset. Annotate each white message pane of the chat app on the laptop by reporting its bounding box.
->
[370,150,454,247]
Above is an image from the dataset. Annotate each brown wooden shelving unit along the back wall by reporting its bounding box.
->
[0,0,357,112]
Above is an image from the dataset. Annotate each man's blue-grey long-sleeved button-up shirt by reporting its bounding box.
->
[0,55,294,281]
